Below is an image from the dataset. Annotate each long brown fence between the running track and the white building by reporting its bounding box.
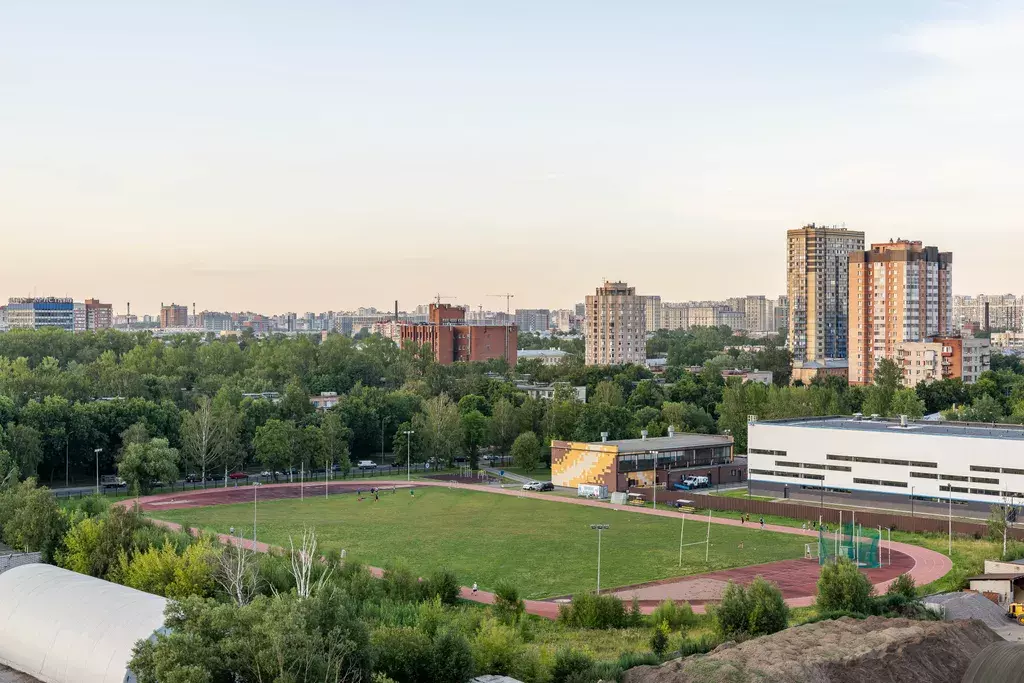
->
[686,492,1024,541]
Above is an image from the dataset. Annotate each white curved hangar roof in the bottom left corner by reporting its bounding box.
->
[0,564,167,683]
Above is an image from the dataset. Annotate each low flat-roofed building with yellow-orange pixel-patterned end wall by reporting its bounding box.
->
[551,430,745,493]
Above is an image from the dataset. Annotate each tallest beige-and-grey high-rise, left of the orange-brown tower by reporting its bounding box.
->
[786,223,864,362]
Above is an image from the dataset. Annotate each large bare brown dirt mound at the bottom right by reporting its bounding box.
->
[624,616,1000,683]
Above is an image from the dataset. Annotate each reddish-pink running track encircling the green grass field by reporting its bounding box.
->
[123,480,952,618]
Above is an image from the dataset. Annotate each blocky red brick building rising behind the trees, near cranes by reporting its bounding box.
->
[400,303,519,366]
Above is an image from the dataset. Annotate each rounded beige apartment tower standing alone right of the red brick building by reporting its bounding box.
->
[585,282,647,366]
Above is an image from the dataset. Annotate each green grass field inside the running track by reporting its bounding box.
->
[154,488,804,598]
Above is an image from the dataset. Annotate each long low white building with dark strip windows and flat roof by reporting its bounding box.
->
[746,416,1024,517]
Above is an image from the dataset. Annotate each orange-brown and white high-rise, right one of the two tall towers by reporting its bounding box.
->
[848,240,952,384]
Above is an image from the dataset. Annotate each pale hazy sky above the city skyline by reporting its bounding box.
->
[0,0,1024,312]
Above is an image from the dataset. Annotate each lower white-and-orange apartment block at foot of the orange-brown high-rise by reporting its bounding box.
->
[895,337,990,387]
